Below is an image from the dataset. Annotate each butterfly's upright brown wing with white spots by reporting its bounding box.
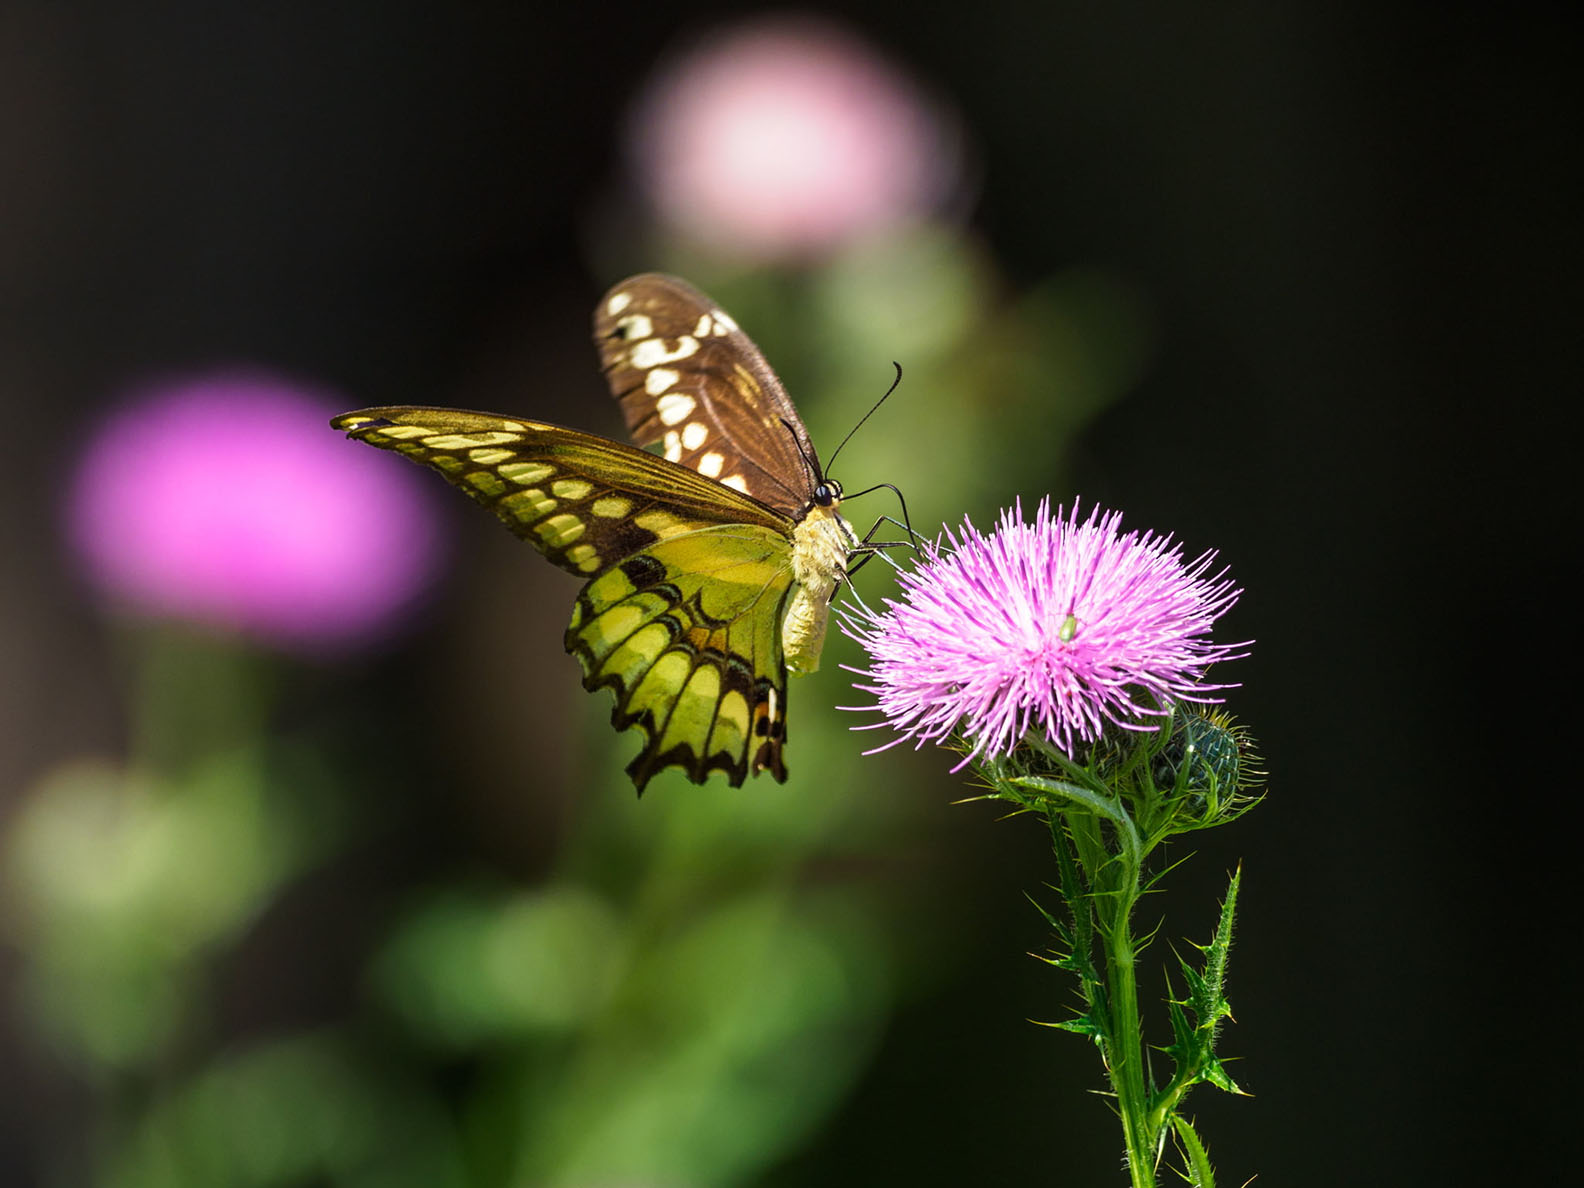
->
[594,281,817,518]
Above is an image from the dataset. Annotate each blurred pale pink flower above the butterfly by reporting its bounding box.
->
[630,17,957,257]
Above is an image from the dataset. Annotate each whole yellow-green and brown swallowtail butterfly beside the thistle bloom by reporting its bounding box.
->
[331,272,871,795]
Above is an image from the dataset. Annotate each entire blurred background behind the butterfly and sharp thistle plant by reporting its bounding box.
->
[0,0,1581,1188]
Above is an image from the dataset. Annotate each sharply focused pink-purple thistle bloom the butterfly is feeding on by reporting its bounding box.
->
[843,499,1247,768]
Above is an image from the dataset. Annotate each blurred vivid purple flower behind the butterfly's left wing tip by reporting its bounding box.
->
[68,371,440,649]
